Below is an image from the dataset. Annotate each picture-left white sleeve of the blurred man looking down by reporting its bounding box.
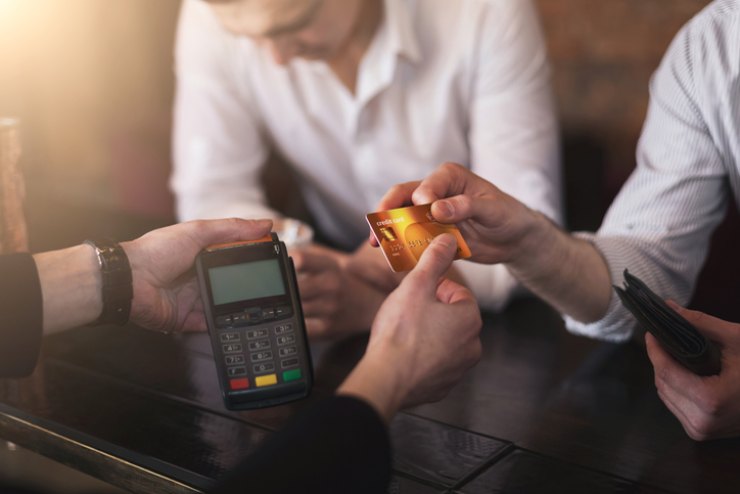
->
[170,0,276,221]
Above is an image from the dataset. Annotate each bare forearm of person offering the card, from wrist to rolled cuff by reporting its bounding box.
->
[507,212,612,322]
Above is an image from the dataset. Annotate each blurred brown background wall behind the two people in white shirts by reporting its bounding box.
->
[0,0,740,320]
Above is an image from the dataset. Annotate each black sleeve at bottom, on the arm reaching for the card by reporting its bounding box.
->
[214,396,391,494]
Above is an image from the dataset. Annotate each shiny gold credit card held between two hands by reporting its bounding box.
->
[367,204,470,272]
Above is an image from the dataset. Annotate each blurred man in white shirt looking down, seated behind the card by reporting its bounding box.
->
[171,0,561,336]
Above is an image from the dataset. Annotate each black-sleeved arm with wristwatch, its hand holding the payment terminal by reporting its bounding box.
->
[0,219,272,377]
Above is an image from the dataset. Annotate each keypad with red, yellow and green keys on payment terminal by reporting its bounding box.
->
[216,314,303,390]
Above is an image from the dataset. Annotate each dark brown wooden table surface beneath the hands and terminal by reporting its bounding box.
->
[0,299,740,494]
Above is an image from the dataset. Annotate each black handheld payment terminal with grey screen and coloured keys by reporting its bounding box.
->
[195,233,313,410]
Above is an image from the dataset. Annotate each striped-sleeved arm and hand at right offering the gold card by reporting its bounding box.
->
[381,0,740,341]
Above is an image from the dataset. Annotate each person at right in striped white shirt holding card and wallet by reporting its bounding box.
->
[380,0,740,440]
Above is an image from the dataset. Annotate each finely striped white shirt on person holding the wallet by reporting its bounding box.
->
[567,0,740,341]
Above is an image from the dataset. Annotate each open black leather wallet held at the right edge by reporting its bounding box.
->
[614,269,722,376]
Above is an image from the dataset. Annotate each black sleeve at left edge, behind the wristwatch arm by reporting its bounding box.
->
[0,253,43,377]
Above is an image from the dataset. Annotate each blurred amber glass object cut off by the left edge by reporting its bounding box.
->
[0,118,28,254]
